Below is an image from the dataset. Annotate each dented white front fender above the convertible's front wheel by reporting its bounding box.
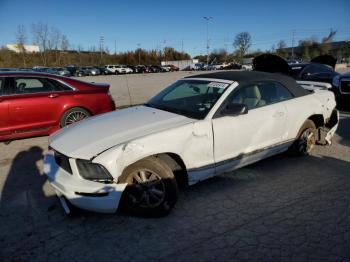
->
[93,120,214,179]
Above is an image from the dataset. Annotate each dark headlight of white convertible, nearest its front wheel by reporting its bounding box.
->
[77,159,113,183]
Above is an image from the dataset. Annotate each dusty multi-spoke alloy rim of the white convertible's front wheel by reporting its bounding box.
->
[127,169,165,208]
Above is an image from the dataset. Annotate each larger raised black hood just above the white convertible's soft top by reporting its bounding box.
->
[253,54,291,75]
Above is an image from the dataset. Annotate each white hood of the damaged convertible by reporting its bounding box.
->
[49,106,195,159]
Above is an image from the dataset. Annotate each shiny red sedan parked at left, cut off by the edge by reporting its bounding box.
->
[0,72,115,141]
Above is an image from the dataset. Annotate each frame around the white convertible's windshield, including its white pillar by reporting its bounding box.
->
[144,77,235,120]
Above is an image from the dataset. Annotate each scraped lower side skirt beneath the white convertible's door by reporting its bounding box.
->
[188,140,294,185]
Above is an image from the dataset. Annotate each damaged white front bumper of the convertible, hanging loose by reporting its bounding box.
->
[44,151,127,213]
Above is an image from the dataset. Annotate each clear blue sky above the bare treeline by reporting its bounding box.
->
[0,0,350,56]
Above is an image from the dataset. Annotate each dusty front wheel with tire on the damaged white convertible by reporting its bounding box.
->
[119,157,178,217]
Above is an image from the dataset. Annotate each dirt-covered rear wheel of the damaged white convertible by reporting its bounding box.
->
[289,119,316,156]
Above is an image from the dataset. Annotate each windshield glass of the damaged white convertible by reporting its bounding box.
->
[145,80,229,119]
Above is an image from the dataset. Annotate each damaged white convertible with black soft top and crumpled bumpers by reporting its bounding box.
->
[45,72,338,216]
